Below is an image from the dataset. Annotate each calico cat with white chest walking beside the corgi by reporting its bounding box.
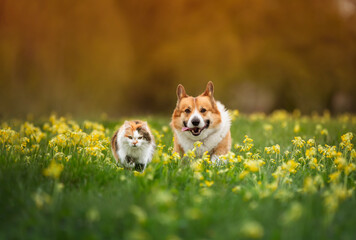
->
[111,120,156,172]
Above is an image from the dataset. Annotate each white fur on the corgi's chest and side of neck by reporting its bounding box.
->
[175,102,231,156]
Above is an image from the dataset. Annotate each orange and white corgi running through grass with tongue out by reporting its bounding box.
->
[171,82,231,162]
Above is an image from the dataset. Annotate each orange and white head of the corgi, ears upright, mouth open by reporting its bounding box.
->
[172,82,221,139]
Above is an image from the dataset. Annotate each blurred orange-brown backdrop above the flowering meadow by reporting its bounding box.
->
[0,0,356,117]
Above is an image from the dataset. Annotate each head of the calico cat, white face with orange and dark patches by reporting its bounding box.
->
[124,120,151,147]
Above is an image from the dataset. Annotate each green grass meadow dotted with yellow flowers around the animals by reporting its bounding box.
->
[0,111,356,239]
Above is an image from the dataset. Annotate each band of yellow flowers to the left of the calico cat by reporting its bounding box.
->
[0,115,110,179]
